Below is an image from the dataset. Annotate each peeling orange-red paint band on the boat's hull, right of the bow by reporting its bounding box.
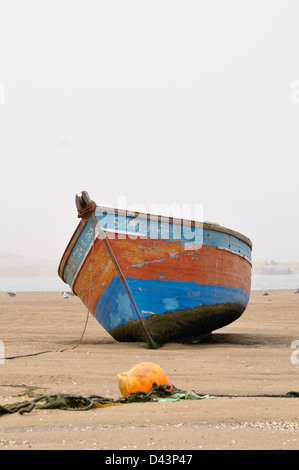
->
[110,238,251,292]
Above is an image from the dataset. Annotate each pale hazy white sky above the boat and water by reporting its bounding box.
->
[0,0,299,261]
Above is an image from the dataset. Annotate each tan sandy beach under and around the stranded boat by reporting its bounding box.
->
[0,291,299,453]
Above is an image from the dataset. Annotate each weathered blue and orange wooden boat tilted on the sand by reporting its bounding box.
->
[59,191,252,347]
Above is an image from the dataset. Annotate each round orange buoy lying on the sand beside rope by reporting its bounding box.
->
[126,362,172,395]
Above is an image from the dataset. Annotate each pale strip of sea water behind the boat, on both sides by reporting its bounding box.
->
[0,274,299,292]
